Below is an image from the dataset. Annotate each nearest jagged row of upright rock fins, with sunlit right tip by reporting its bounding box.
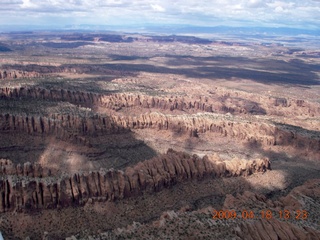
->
[0,150,270,212]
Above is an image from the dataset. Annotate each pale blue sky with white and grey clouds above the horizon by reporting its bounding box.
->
[0,0,320,29]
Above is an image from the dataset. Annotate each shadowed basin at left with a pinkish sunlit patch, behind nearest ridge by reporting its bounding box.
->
[0,103,157,172]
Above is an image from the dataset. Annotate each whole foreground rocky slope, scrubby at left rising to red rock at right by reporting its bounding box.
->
[67,179,320,240]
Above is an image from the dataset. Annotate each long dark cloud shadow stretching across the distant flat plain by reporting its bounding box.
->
[2,56,320,86]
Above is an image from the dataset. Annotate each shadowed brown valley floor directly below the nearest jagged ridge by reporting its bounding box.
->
[0,146,278,239]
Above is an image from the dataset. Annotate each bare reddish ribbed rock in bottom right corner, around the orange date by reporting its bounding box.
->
[223,179,320,239]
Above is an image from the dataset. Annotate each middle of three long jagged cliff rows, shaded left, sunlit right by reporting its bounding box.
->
[0,112,320,153]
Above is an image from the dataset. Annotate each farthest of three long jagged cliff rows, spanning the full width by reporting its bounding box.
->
[0,88,320,117]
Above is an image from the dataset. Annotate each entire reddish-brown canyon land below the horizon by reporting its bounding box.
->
[0,32,320,239]
